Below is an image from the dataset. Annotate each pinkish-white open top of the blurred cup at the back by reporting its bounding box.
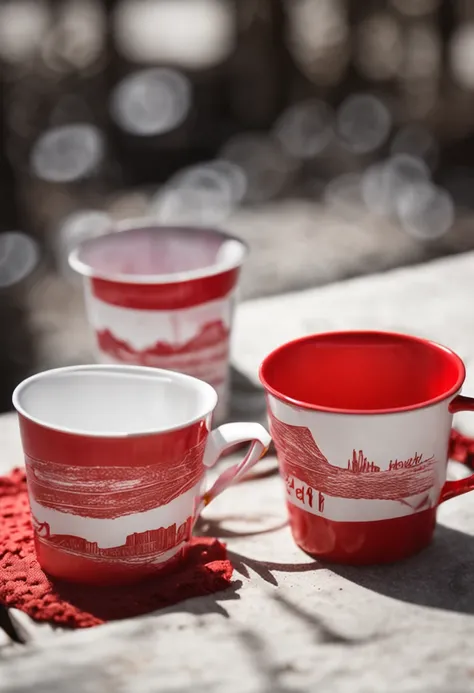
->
[69,225,246,282]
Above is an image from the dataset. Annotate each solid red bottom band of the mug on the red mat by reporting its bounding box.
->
[35,537,186,587]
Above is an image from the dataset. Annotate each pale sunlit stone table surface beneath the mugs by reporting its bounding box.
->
[4,254,474,693]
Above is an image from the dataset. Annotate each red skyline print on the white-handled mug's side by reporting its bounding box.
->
[26,436,207,570]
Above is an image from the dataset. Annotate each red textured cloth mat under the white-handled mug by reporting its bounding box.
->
[0,469,232,628]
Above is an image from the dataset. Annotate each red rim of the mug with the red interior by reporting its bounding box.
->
[258,330,466,416]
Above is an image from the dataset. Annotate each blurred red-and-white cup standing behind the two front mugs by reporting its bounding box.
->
[69,220,247,422]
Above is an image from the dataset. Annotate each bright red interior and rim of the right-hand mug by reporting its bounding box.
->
[260,332,465,413]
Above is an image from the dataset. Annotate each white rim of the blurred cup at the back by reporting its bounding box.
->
[68,217,249,285]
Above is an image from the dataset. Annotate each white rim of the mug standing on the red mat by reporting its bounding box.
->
[12,364,218,439]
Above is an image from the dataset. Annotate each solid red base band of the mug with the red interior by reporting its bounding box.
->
[288,503,436,565]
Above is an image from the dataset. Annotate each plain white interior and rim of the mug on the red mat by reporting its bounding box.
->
[13,366,217,436]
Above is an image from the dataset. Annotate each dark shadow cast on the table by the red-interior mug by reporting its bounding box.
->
[327,525,474,614]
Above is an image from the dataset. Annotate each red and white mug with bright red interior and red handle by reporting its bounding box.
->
[260,332,474,564]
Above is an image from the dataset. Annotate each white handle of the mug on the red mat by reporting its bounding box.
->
[195,423,272,520]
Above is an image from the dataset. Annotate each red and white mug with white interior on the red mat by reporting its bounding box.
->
[13,365,270,584]
